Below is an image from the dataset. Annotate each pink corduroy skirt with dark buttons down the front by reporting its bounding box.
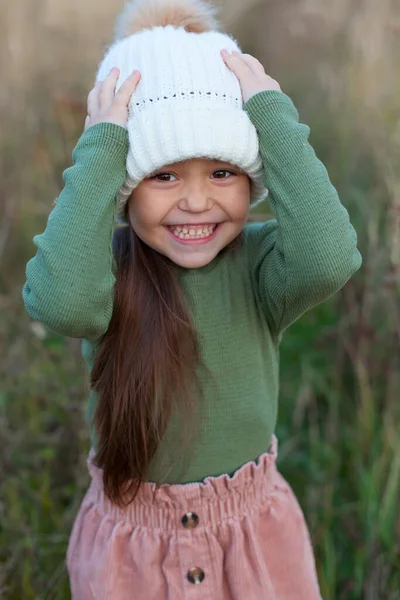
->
[67,437,321,600]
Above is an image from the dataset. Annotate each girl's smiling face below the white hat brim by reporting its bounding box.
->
[128,158,250,269]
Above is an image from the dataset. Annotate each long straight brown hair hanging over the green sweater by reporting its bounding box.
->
[91,225,242,506]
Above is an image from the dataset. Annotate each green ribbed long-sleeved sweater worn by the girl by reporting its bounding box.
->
[23,91,362,483]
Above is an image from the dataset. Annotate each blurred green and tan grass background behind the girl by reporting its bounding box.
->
[0,0,400,600]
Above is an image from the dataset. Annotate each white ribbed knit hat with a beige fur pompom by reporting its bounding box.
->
[96,0,268,222]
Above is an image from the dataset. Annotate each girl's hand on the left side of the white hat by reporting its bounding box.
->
[85,67,141,130]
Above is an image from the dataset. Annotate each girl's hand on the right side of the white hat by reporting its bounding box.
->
[221,49,282,103]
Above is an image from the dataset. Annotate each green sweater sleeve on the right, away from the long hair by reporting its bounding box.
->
[244,90,362,338]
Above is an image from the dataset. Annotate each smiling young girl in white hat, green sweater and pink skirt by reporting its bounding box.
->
[23,0,361,600]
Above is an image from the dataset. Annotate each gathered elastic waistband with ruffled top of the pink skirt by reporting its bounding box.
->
[87,436,280,533]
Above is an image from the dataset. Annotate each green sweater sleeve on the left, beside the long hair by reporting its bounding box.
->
[22,123,128,341]
